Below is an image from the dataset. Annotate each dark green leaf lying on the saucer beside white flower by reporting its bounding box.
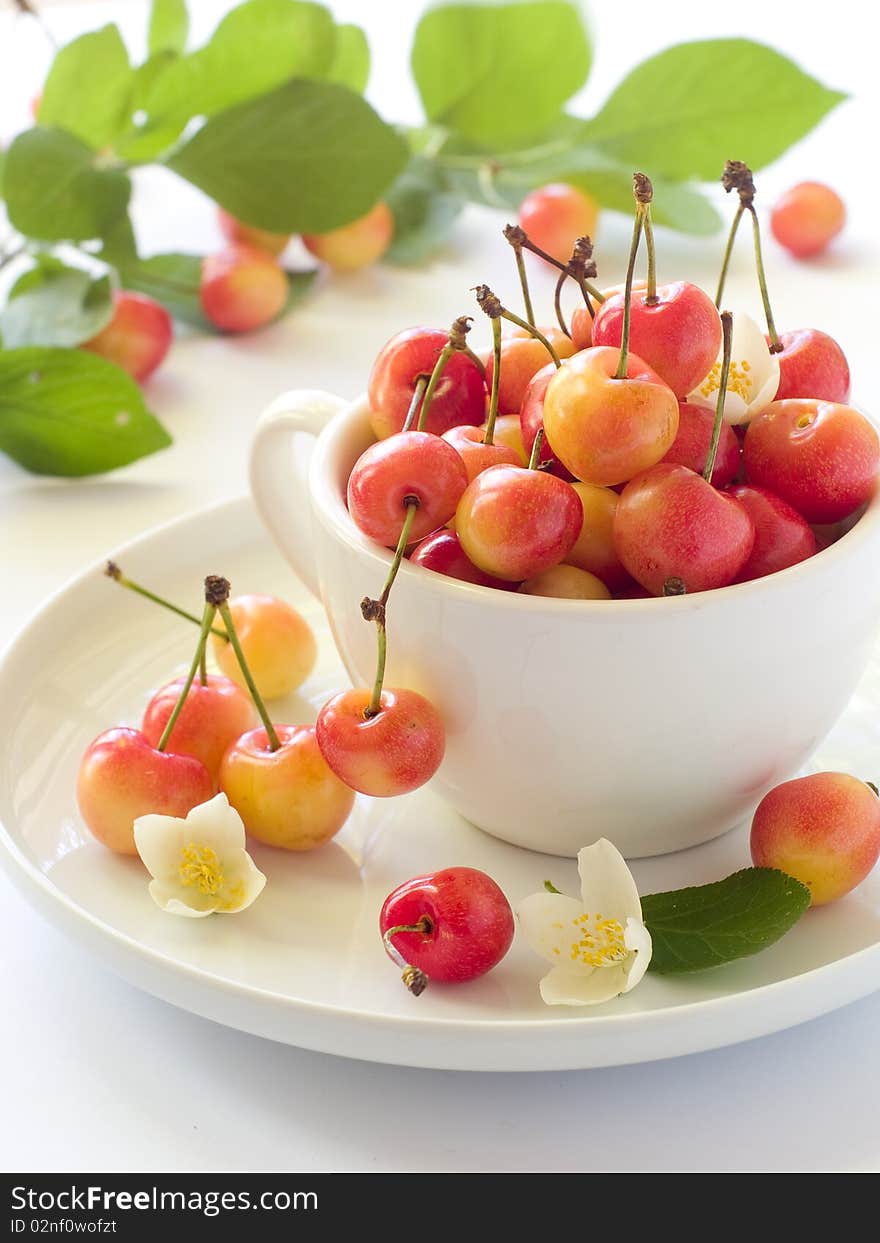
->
[641,868,810,975]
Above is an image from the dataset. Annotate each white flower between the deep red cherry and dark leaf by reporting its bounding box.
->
[517,838,651,1006]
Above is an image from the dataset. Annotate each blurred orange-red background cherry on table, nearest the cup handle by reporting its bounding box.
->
[199,246,288,332]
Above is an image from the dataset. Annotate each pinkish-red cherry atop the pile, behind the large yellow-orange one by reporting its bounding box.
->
[593,281,721,398]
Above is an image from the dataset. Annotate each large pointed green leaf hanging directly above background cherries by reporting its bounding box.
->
[167,81,408,232]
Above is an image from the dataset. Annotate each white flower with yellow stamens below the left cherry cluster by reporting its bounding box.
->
[134,794,266,917]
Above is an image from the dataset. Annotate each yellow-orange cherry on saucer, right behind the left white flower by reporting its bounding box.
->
[220,725,354,850]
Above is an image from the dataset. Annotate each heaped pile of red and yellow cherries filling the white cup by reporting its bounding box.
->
[348,163,880,599]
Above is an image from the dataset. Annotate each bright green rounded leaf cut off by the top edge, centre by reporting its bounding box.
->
[413,0,592,148]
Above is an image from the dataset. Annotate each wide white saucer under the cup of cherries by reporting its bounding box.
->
[0,498,880,1070]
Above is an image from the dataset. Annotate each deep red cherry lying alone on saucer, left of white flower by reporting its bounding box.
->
[379,868,513,984]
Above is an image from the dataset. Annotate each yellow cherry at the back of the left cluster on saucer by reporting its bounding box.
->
[211,594,318,699]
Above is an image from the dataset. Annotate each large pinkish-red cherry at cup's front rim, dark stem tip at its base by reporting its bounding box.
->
[614,462,754,595]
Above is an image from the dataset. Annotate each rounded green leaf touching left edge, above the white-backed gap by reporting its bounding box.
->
[4,126,132,241]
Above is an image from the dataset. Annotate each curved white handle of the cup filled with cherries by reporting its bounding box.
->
[250,389,348,595]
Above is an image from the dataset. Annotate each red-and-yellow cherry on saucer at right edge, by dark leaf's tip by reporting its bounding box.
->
[751,772,880,906]
